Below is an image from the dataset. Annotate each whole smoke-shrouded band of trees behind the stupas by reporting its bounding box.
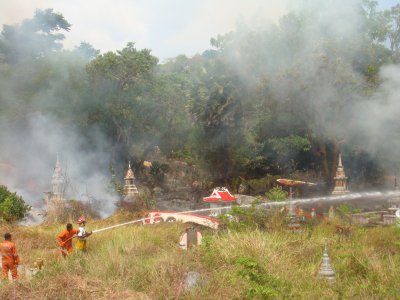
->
[0,1,400,211]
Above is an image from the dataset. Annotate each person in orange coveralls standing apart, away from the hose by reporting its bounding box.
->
[0,232,20,280]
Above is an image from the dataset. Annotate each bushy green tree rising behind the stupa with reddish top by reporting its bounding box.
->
[82,43,163,161]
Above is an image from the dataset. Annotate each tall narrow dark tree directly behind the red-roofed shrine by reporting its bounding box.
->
[192,61,246,185]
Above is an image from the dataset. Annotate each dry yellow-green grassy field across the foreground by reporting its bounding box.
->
[0,214,400,299]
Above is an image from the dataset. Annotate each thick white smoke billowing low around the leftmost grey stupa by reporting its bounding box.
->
[0,113,117,215]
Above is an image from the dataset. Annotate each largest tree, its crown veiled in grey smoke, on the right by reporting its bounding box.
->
[206,6,380,183]
